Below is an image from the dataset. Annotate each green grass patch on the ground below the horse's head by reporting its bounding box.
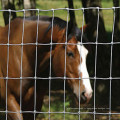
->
[37,90,88,120]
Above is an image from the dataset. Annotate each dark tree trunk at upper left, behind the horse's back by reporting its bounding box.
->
[1,0,17,25]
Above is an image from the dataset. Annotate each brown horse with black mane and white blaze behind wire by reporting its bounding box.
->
[0,18,92,120]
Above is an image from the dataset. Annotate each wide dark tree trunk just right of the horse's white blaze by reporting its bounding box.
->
[82,0,110,105]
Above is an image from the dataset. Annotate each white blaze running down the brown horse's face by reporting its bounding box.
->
[77,42,92,95]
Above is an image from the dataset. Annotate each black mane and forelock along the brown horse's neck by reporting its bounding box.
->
[19,16,88,42]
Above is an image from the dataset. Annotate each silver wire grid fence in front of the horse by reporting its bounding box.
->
[0,7,120,120]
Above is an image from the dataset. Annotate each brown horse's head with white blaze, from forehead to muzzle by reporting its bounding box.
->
[52,26,92,102]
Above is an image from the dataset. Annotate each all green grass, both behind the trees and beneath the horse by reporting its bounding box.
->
[0,0,116,120]
